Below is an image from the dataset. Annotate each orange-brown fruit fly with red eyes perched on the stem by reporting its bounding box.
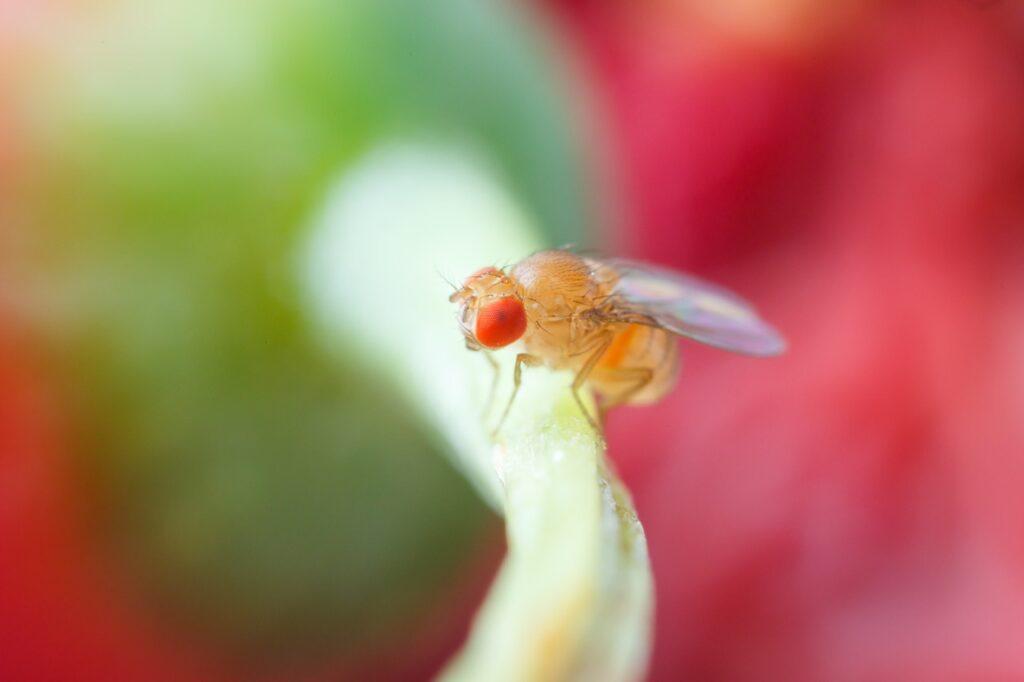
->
[450,249,785,433]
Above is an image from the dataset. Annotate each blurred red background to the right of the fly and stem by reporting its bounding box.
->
[553,0,1024,680]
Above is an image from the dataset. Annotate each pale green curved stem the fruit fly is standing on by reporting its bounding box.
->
[302,144,652,682]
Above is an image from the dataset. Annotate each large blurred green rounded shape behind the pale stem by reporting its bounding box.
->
[0,0,588,662]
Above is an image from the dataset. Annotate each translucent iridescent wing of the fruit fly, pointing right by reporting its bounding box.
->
[600,259,785,355]
